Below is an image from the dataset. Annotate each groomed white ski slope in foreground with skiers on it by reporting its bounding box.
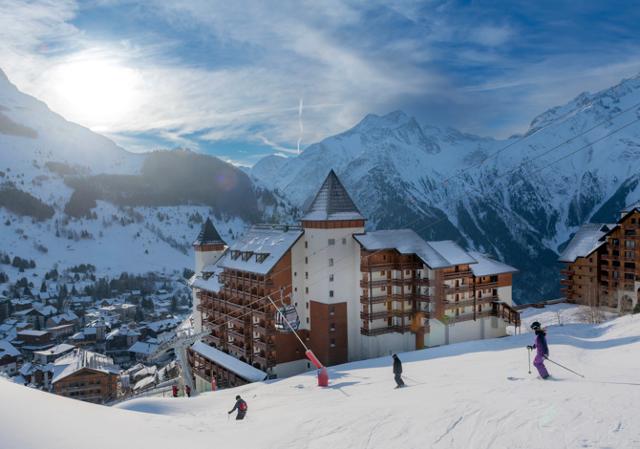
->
[0,306,640,449]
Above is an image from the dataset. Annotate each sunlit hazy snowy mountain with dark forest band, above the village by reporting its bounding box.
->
[0,71,270,280]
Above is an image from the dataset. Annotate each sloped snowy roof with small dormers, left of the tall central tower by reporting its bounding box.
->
[218,225,303,274]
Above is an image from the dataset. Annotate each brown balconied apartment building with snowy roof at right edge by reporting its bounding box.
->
[559,202,640,312]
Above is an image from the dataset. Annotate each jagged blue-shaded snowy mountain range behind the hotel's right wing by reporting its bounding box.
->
[251,77,640,303]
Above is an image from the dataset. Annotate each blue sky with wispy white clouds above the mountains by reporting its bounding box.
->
[0,0,640,165]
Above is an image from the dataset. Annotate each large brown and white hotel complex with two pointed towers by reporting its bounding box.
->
[189,171,520,391]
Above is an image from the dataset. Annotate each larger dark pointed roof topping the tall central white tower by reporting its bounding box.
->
[302,170,364,221]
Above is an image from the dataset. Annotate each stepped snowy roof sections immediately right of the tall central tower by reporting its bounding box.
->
[353,229,476,268]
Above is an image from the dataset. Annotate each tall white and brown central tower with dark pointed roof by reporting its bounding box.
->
[301,170,365,365]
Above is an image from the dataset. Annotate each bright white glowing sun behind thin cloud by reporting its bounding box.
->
[49,58,141,131]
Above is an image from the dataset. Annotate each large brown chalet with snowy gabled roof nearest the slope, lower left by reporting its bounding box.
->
[51,348,120,403]
